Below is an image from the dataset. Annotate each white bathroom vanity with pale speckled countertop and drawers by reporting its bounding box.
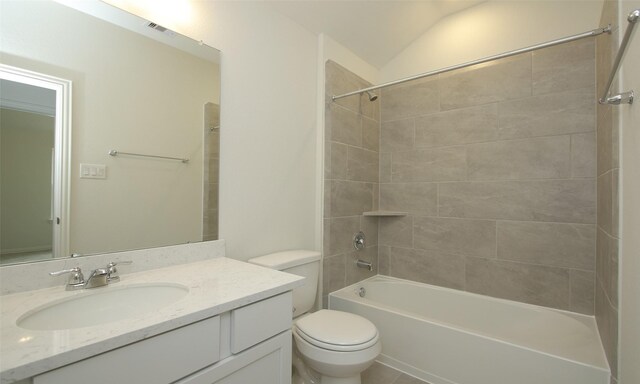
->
[0,257,302,384]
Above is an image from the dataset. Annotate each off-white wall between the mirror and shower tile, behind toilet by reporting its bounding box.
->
[104,0,321,260]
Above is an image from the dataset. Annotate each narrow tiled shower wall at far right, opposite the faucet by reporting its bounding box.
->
[595,0,620,382]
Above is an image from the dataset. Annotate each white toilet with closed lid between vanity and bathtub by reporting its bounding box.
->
[249,250,382,384]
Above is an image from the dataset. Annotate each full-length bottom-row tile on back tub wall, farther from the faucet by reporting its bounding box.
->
[465,257,570,309]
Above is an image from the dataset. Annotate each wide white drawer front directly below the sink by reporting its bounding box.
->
[33,316,220,384]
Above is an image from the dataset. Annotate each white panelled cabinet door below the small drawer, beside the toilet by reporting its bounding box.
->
[175,330,292,384]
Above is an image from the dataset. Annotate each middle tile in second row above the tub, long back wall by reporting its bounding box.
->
[413,217,496,258]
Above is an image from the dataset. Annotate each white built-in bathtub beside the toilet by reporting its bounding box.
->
[329,276,609,384]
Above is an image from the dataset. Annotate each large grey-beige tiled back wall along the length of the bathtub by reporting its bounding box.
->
[378,39,596,314]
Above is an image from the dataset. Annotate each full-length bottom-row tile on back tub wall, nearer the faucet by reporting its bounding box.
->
[389,247,465,289]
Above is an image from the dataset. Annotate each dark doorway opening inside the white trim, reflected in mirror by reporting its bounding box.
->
[0,80,56,264]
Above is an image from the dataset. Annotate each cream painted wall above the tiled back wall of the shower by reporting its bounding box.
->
[380,0,602,82]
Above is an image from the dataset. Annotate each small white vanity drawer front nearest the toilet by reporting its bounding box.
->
[231,292,293,354]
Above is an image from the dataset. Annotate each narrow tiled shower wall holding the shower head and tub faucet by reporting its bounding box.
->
[323,61,380,307]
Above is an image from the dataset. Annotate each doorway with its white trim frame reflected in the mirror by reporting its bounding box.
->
[0,66,70,264]
